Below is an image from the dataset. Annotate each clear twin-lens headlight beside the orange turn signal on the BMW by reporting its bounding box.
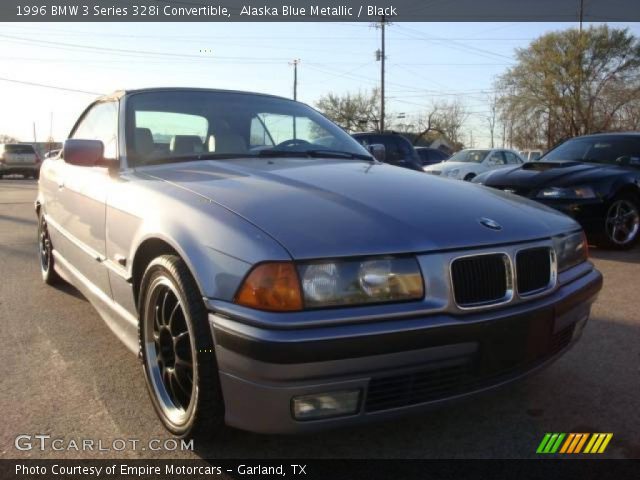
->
[298,258,424,308]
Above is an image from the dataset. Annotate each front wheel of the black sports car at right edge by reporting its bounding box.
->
[601,193,640,250]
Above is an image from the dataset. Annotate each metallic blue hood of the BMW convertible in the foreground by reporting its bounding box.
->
[144,158,576,259]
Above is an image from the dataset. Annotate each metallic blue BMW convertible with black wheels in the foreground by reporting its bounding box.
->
[36,89,602,436]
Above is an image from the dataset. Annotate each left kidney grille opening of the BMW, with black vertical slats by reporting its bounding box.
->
[451,254,507,307]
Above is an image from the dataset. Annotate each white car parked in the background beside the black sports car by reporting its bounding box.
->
[424,148,524,181]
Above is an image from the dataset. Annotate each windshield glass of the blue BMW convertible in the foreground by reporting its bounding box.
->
[127,91,372,165]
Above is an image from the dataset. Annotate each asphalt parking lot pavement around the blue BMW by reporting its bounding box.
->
[0,179,640,458]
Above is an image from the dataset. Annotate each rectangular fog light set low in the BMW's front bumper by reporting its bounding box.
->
[292,390,360,420]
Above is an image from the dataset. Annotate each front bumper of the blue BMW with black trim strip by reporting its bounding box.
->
[209,268,602,433]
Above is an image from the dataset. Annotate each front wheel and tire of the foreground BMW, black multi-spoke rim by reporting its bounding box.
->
[138,255,225,438]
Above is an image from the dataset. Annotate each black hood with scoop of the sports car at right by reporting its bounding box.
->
[478,161,622,189]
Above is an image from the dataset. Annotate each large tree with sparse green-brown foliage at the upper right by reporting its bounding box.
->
[497,25,640,147]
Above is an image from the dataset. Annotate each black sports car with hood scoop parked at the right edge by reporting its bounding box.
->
[474,132,640,249]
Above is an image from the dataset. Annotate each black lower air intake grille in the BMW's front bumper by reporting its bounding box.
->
[365,324,575,412]
